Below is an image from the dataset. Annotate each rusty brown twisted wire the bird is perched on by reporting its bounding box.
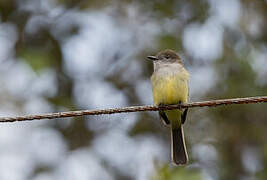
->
[0,96,267,122]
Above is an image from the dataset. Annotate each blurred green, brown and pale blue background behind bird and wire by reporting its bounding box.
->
[0,0,267,180]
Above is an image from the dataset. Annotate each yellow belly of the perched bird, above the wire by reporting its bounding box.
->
[151,73,188,105]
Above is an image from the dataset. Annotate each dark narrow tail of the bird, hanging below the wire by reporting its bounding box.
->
[171,125,188,165]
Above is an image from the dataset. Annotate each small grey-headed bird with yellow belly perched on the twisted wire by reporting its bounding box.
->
[147,49,189,165]
